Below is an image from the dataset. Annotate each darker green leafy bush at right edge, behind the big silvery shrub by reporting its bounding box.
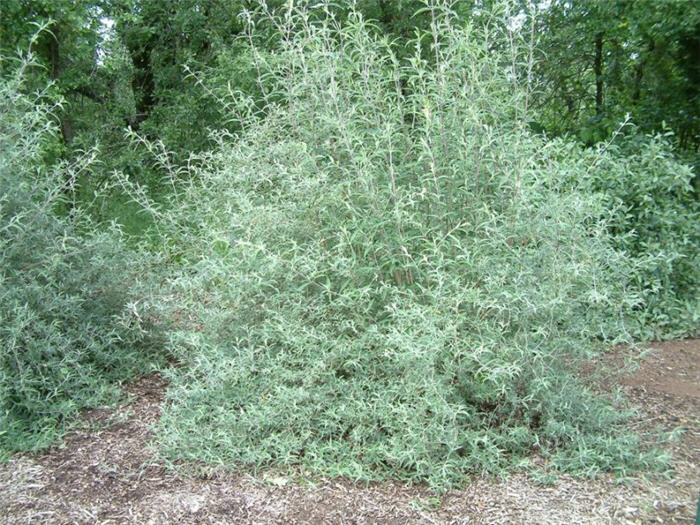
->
[588,135,700,340]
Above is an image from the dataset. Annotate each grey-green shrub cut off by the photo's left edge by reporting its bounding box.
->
[0,55,165,454]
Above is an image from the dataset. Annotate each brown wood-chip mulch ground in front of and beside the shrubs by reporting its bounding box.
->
[0,340,700,525]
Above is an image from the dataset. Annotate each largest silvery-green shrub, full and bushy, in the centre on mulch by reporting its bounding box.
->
[150,4,664,487]
